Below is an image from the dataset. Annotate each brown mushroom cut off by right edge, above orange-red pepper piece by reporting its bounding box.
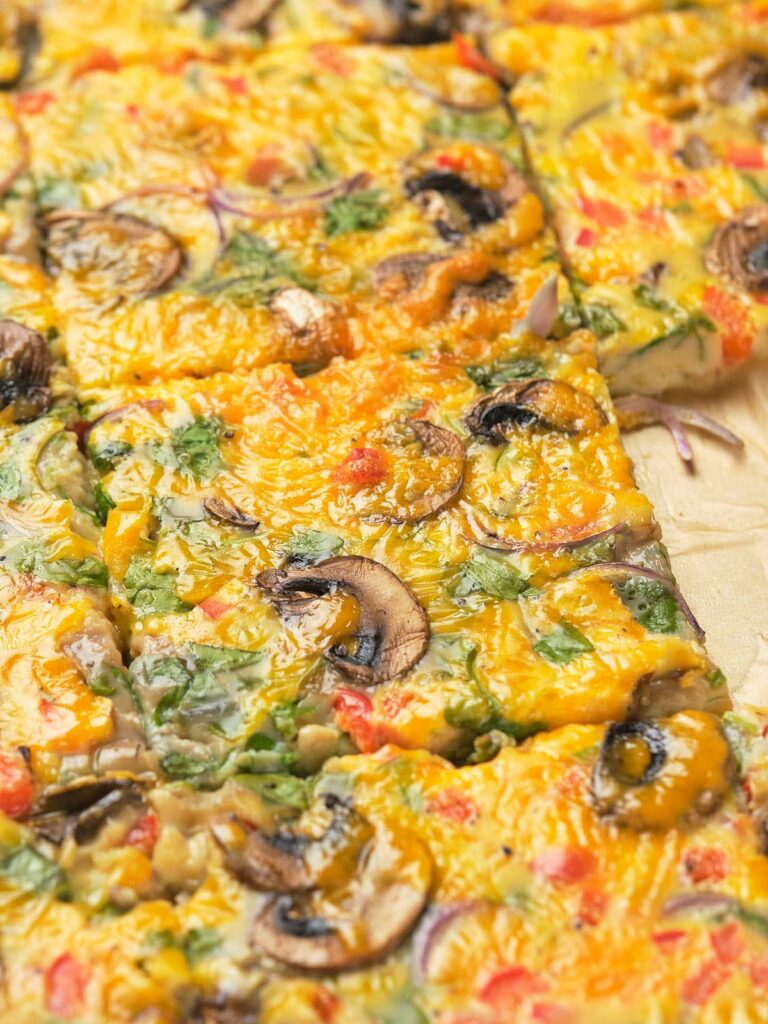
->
[705,203,768,292]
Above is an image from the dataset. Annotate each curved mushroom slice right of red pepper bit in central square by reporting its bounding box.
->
[365,419,466,522]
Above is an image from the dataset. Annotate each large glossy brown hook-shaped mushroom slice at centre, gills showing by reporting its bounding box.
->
[256,555,429,686]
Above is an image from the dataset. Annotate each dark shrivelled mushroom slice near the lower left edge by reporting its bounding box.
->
[30,776,144,844]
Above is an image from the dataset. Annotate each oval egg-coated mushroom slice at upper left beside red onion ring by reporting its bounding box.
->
[44,210,182,296]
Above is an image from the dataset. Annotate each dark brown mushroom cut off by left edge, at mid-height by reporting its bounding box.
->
[0,319,51,423]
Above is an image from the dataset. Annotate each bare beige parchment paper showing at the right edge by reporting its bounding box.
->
[625,361,768,710]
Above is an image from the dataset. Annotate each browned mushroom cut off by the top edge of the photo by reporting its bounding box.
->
[337,0,457,46]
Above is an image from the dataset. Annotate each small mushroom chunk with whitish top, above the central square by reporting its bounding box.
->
[269,285,348,361]
